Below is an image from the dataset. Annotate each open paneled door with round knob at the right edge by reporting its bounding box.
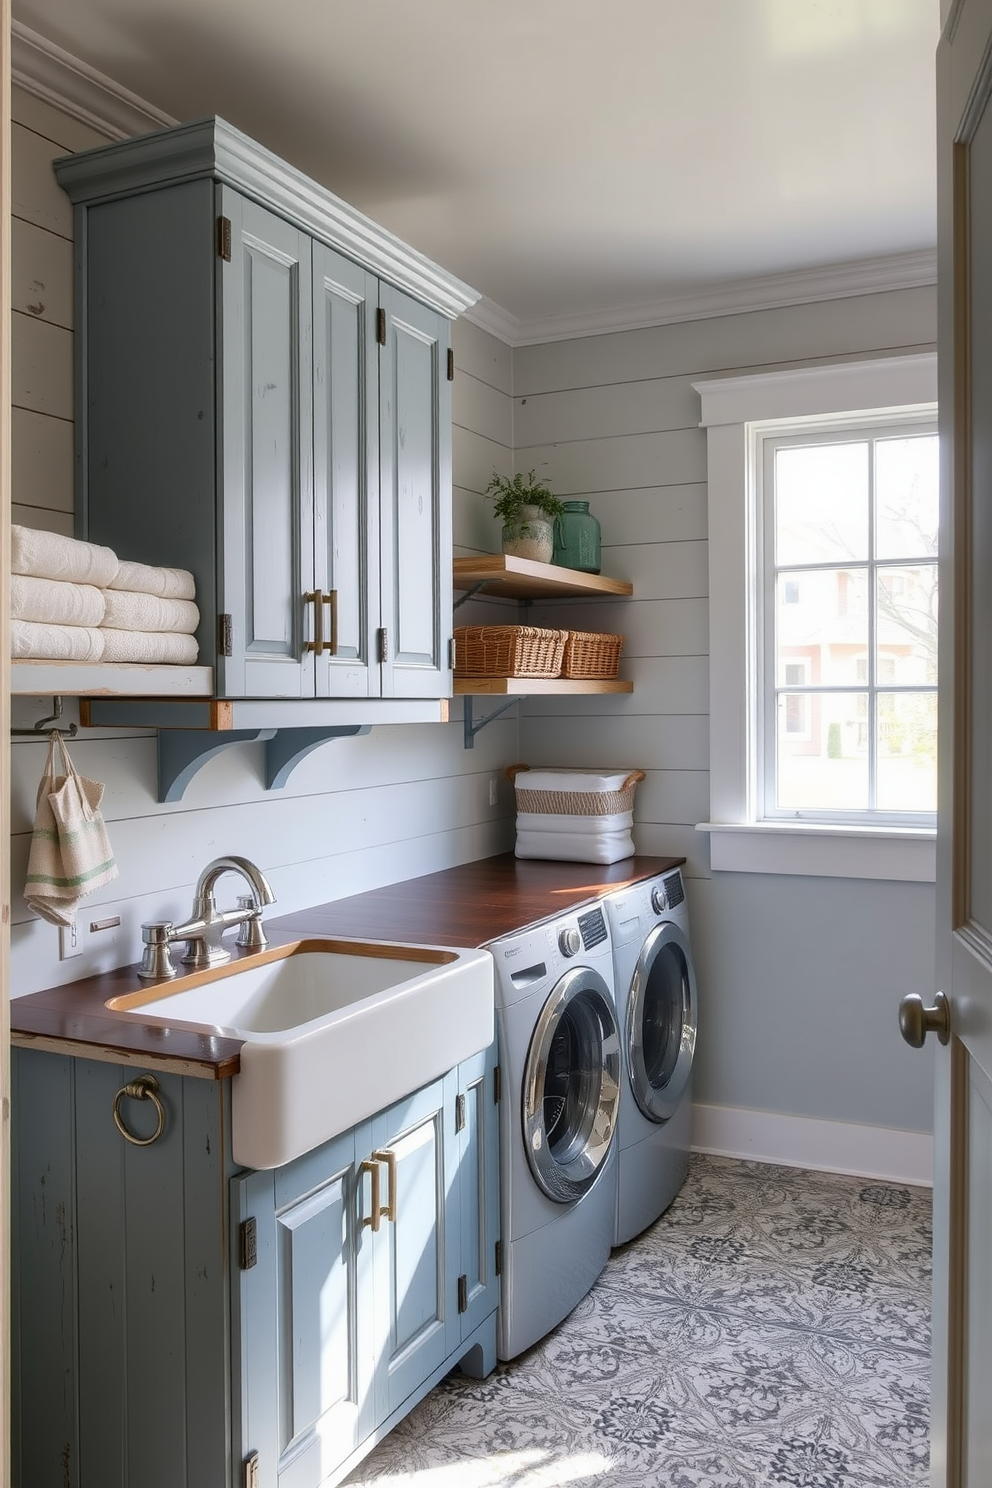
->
[933,0,992,1488]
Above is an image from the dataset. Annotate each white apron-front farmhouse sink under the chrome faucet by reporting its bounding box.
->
[107,939,494,1168]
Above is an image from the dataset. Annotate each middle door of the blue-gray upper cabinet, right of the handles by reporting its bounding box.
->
[314,243,379,698]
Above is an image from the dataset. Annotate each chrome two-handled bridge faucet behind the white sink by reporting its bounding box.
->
[138,857,275,982]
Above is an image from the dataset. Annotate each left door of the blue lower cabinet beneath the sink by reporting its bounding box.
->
[233,1129,373,1488]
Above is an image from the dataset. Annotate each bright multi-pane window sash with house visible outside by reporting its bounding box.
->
[759,423,937,823]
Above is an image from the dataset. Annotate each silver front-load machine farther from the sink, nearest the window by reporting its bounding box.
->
[604,869,696,1245]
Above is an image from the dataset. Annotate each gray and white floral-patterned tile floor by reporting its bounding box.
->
[347,1158,931,1488]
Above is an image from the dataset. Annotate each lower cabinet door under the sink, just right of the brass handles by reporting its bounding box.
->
[373,1074,460,1417]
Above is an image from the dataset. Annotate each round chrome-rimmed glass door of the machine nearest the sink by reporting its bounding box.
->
[522,966,620,1204]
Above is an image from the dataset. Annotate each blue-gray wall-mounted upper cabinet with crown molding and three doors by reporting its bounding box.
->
[55,119,476,698]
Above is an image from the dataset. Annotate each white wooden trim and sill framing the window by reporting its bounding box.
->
[693,353,937,882]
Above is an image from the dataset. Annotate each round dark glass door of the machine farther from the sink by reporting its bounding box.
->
[625,921,696,1122]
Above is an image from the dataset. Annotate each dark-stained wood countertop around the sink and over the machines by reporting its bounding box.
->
[10,853,686,1080]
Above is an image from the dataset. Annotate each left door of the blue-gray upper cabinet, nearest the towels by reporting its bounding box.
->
[219,187,314,696]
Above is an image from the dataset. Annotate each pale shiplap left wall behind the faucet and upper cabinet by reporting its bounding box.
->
[10,78,518,995]
